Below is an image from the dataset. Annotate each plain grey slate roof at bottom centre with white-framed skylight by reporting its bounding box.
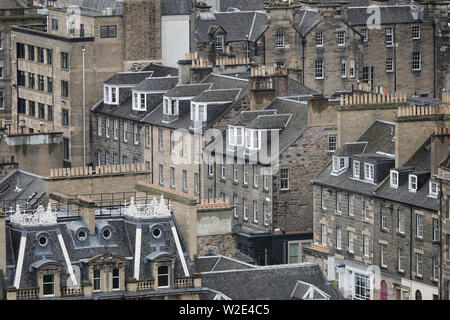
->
[201,262,338,300]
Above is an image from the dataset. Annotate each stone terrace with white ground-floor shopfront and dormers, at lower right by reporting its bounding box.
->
[313,100,448,300]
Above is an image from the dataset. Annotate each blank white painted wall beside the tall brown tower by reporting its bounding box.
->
[161,16,190,68]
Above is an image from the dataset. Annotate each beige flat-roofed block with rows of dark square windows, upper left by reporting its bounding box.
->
[12,0,167,166]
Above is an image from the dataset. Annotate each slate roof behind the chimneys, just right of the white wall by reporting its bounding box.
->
[195,11,267,42]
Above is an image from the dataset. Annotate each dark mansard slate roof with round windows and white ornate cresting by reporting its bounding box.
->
[5,209,195,287]
